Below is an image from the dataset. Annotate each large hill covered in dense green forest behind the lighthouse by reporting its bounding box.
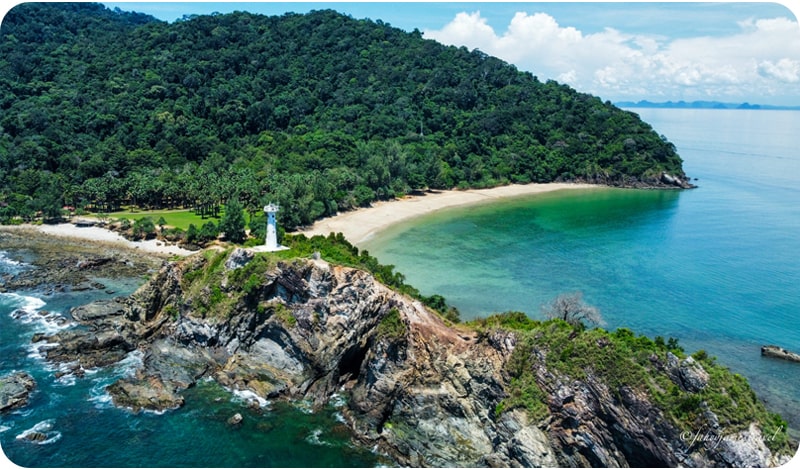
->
[0,3,683,227]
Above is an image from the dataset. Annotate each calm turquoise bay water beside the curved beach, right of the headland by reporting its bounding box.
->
[362,109,800,433]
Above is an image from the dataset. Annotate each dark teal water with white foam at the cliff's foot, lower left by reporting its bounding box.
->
[0,260,381,467]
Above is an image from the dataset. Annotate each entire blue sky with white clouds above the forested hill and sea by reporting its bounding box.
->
[81,2,800,105]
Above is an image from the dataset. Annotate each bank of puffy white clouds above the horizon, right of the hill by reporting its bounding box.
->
[425,12,800,104]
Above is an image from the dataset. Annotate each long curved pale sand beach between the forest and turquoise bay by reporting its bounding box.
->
[298,183,598,246]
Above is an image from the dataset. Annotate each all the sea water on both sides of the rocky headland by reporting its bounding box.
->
[0,109,800,467]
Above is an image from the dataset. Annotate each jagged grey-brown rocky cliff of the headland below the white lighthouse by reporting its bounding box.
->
[34,250,790,467]
